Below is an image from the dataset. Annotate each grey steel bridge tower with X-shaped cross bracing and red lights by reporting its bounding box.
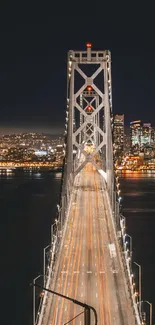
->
[65,43,113,198]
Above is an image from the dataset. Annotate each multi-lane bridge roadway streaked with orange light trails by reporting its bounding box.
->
[43,163,135,325]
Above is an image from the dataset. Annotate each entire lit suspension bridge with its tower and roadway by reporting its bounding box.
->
[33,43,142,325]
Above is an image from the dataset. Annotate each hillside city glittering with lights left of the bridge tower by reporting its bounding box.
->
[0,133,64,171]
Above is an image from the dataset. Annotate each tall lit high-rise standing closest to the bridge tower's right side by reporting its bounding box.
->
[113,114,124,156]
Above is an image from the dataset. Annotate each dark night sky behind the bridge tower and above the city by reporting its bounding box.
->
[0,3,155,132]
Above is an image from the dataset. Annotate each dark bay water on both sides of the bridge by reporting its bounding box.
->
[0,172,155,325]
